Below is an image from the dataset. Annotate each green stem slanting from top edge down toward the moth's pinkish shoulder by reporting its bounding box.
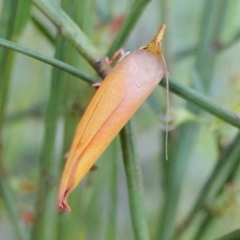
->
[107,0,150,56]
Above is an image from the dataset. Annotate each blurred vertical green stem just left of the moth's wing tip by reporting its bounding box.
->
[31,39,65,240]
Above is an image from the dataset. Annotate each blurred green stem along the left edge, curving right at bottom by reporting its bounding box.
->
[0,0,27,240]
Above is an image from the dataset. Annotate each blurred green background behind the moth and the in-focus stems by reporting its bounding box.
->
[0,0,240,240]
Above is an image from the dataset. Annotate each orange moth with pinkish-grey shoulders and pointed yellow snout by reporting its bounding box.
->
[58,25,166,212]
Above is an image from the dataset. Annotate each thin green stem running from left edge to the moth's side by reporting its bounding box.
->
[0,38,97,83]
